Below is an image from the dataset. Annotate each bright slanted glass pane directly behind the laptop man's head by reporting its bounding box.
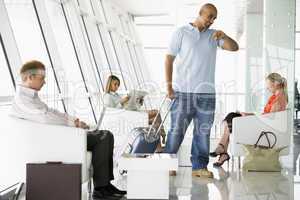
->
[5,0,58,101]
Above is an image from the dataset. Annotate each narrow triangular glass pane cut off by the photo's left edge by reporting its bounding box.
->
[0,37,15,96]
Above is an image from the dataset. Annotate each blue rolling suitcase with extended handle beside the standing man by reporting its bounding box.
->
[123,97,174,154]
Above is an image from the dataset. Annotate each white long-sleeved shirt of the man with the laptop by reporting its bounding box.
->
[10,85,76,126]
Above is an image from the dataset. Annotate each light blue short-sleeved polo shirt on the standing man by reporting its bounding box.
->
[167,24,224,93]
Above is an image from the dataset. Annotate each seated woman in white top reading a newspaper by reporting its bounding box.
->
[103,75,166,152]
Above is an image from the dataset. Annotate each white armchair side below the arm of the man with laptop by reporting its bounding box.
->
[0,116,87,185]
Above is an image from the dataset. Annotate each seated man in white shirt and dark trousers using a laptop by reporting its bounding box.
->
[11,60,126,199]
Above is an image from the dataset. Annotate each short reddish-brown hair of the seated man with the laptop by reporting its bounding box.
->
[20,60,46,80]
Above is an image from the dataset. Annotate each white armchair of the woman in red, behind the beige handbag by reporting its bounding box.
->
[230,110,292,156]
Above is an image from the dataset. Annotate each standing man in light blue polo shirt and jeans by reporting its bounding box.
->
[165,4,239,178]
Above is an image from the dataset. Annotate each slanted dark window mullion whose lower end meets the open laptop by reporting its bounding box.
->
[60,3,97,122]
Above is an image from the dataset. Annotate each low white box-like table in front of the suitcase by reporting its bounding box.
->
[119,154,178,199]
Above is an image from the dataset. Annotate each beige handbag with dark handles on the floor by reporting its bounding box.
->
[243,131,286,172]
